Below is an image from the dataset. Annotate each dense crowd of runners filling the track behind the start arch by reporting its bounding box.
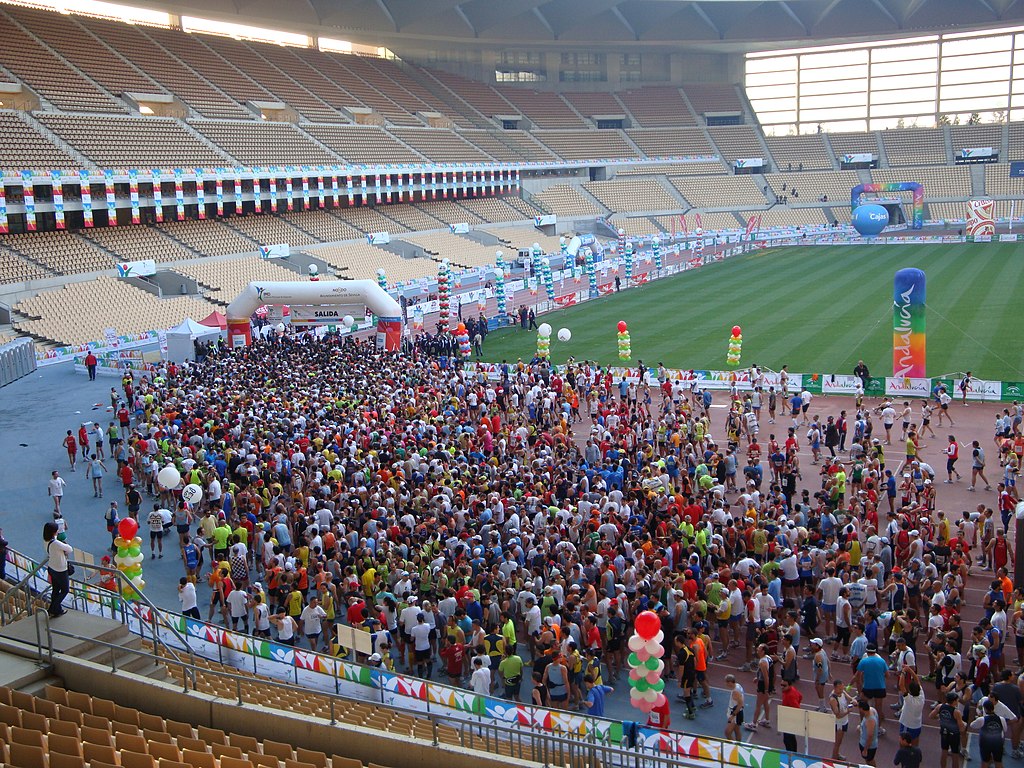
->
[49,334,1024,768]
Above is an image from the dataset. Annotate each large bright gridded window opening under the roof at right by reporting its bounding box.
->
[745,28,1024,135]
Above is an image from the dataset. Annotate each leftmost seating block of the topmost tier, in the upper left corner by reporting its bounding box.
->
[0,6,127,114]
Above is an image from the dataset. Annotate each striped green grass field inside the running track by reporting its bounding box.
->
[484,243,1024,381]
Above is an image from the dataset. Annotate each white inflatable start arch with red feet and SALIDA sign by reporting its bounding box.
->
[226,280,401,352]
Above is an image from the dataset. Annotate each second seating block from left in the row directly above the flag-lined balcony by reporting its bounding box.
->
[36,115,225,169]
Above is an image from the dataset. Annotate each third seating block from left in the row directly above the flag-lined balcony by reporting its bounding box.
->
[190,120,338,166]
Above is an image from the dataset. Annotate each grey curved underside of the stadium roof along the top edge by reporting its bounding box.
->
[142,0,1024,52]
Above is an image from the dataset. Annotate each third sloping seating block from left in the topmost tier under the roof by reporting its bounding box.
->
[81,16,253,120]
